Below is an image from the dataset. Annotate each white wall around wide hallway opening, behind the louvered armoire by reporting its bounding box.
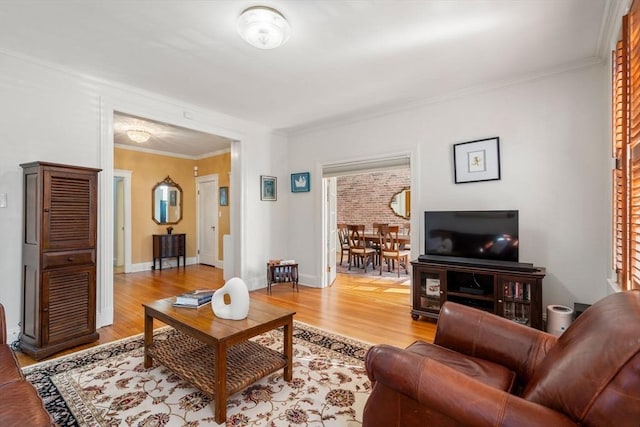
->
[0,54,288,339]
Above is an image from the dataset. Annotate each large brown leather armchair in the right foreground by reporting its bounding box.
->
[363,291,640,427]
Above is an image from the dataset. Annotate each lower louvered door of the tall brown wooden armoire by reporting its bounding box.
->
[42,266,96,346]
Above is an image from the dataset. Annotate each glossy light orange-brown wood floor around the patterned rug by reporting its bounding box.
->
[16,265,435,366]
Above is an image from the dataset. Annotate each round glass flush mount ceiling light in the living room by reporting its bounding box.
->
[238,6,291,49]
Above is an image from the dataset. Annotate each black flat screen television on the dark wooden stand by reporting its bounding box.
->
[424,210,518,263]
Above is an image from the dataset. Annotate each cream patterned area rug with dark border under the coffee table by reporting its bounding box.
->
[23,322,371,427]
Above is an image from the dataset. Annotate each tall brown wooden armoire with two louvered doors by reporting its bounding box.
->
[20,162,100,360]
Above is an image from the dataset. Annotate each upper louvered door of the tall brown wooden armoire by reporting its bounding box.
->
[41,170,97,250]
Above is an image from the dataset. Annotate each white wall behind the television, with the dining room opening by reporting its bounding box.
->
[289,65,610,306]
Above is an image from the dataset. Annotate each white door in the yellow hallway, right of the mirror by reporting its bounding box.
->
[197,177,218,267]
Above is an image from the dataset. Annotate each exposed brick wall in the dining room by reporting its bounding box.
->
[337,168,411,229]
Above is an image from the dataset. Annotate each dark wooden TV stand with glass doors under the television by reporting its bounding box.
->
[411,261,546,330]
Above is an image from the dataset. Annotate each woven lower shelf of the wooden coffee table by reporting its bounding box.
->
[147,331,287,398]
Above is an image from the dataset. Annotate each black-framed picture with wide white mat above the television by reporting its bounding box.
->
[453,137,500,184]
